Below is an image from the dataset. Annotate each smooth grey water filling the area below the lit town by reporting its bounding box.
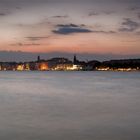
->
[0,72,140,140]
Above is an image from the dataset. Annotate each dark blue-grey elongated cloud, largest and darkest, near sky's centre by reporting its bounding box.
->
[52,24,92,35]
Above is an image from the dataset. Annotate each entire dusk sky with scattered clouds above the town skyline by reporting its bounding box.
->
[0,0,140,61]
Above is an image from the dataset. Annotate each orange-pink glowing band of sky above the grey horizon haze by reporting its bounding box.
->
[0,33,140,55]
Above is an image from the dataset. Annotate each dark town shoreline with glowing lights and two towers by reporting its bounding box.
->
[0,55,140,71]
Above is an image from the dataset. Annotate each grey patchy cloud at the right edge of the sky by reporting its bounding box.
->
[119,18,140,32]
